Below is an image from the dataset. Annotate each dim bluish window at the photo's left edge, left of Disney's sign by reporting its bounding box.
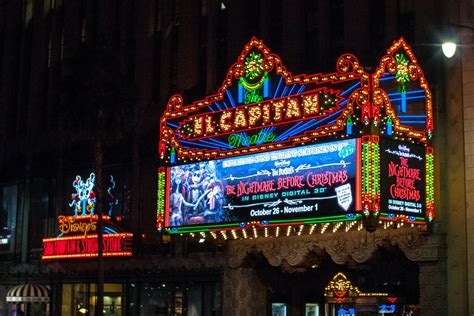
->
[0,185,18,251]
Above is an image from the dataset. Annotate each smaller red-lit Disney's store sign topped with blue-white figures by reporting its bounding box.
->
[42,173,133,260]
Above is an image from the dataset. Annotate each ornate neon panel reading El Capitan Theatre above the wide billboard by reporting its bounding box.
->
[159,39,370,163]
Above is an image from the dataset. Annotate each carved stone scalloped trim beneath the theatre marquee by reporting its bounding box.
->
[228,228,443,267]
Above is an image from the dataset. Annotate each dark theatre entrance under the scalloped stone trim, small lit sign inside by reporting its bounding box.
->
[247,246,419,316]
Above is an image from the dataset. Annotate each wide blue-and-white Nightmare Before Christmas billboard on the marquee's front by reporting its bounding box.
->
[165,139,360,227]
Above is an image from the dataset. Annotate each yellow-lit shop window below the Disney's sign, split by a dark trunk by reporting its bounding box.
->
[61,283,122,316]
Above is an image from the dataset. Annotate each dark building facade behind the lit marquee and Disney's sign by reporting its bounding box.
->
[0,0,474,315]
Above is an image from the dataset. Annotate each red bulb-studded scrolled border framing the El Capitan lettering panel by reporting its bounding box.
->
[158,37,370,163]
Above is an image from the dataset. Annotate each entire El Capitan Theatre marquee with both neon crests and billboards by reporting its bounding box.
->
[157,38,434,239]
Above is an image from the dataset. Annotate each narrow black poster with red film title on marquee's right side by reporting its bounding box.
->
[380,138,426,216]
